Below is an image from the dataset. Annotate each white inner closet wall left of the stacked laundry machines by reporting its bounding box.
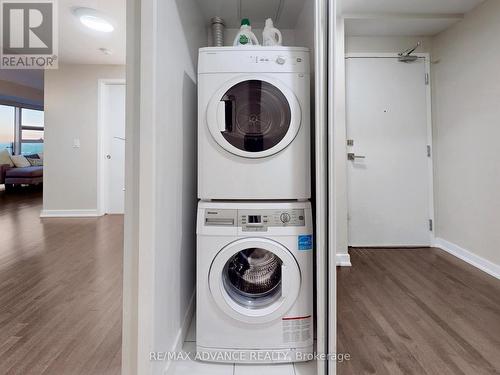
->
[153,0,207,374]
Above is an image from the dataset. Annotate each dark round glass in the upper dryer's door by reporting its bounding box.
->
[221,80,291,152]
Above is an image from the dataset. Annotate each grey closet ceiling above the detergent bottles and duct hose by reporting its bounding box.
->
[196,0,304,29]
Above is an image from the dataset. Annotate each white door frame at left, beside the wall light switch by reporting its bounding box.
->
[97,78,126,216]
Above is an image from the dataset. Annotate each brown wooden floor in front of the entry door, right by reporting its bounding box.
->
[337,248,500,375]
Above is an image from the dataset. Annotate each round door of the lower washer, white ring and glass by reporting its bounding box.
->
[209,238,301,323]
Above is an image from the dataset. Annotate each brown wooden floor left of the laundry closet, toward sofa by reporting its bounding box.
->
[0,185,123,375]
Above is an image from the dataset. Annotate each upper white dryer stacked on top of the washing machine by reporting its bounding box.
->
[198,47,311,200]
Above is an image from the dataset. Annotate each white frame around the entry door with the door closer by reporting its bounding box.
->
[345,52,436,246]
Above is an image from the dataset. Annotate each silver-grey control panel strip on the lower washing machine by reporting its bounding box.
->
[205,209,306,232]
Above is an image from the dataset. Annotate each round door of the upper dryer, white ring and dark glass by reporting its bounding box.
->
[207,75,302,158]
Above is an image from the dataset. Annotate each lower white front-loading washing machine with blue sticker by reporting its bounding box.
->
[196,202,313,363]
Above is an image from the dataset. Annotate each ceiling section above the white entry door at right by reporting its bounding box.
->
[341,0,485,36]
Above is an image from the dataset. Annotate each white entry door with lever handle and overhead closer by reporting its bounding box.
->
[346,58,432,246]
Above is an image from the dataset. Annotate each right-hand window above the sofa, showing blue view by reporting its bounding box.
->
[21,108,44,155]
